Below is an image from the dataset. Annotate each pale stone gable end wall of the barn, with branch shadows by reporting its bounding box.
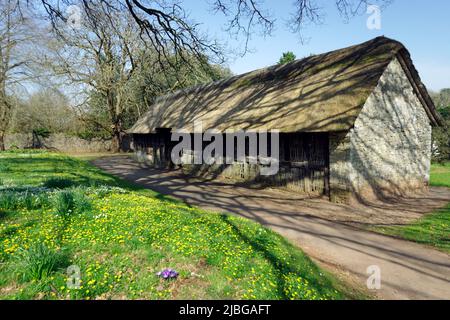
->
[330,59,432,202]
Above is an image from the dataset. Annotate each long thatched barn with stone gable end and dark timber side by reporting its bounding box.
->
[130,37,441,201]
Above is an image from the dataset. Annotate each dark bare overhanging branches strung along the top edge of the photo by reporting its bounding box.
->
[41,0,394,60]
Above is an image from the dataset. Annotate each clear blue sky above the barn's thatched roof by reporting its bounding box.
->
[183,0,450,90]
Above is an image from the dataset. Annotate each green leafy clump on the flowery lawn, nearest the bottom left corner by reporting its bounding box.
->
[15,243,69,281]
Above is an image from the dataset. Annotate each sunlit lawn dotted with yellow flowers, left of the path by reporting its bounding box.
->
[0,151,354,299]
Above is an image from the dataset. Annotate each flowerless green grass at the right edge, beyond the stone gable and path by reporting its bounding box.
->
[376,163,450,253]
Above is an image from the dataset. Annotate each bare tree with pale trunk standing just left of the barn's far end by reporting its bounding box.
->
[46,1,147,151]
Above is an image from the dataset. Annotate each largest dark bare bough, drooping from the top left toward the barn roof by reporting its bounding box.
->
[41,0,224,66]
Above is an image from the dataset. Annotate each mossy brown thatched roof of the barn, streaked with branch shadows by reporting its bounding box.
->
[129,37,440,133]
